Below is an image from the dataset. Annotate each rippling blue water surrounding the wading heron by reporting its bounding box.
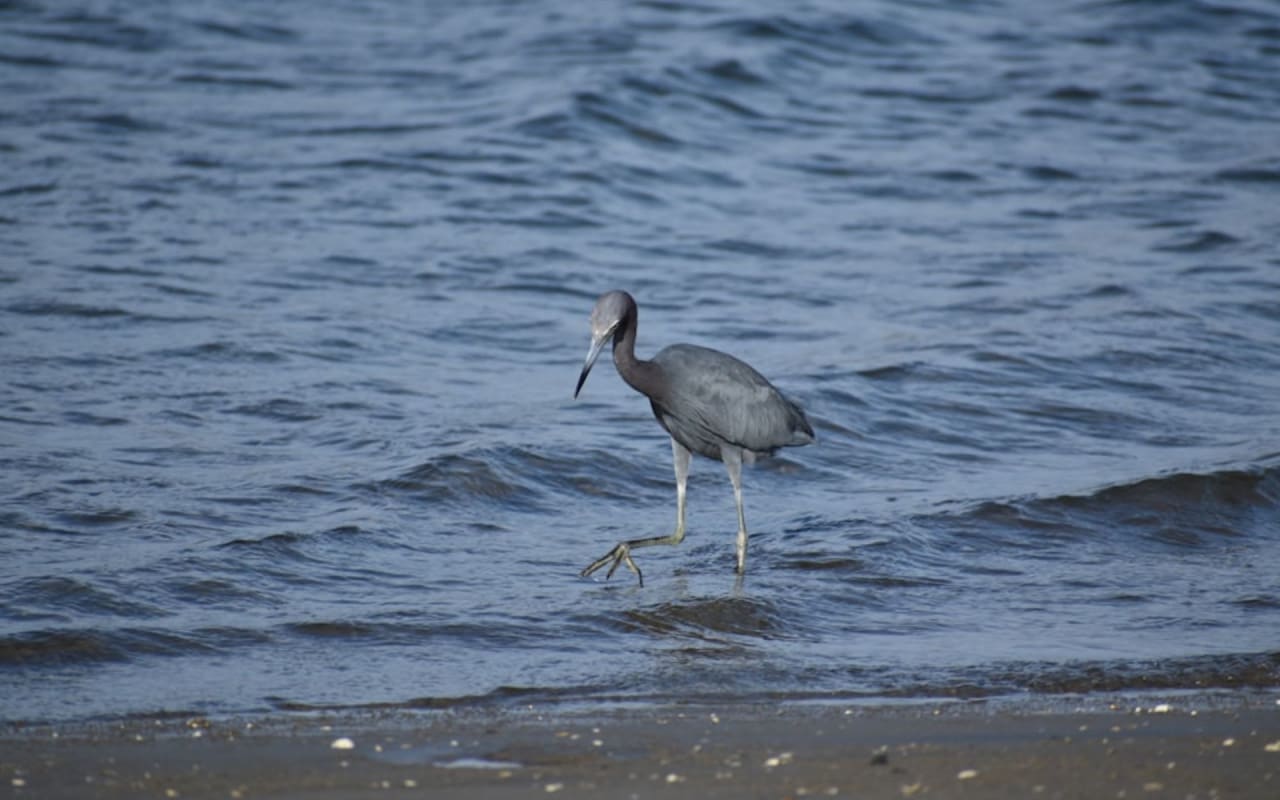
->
[0,0,1280,719]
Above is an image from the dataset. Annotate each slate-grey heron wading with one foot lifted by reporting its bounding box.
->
[573,292,814,586]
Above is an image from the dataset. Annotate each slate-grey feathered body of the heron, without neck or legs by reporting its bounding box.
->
[649,344,814,458]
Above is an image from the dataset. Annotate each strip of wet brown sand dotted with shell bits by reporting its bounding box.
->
[0,696,1280,800]
